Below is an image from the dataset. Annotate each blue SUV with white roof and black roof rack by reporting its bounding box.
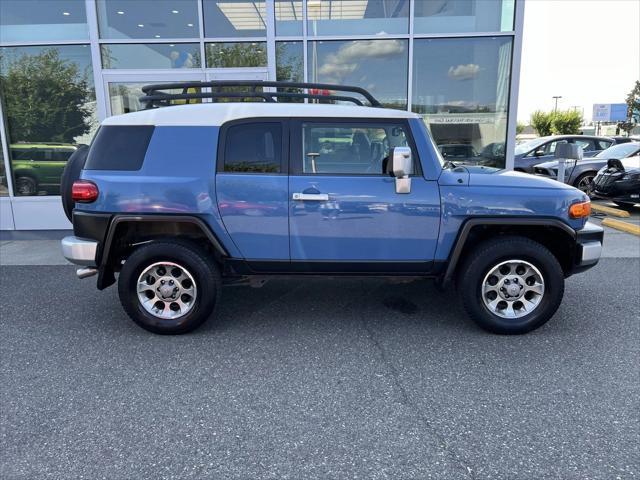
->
[62,82,603,334]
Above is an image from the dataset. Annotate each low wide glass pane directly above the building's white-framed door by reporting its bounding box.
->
[100,43,200,69]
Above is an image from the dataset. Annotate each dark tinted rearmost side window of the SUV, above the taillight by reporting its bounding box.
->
[84,125,154,170]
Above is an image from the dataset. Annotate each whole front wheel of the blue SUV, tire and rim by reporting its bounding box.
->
[458,236,564,334]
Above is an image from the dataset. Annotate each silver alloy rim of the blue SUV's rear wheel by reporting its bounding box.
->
[137,262,198,320]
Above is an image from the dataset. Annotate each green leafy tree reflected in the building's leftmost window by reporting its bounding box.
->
[0,48,93,143]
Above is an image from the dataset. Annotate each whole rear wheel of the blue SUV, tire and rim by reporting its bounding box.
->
[118,240,220,334]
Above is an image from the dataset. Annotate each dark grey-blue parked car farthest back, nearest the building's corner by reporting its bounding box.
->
[514,135,615,173]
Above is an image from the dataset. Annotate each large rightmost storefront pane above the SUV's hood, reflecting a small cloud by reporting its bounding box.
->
[412,37,512,168]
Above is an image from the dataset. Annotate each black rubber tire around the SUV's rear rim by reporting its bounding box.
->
[118,240,221,335]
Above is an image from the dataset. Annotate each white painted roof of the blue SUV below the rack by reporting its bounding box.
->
[102,102,420,126]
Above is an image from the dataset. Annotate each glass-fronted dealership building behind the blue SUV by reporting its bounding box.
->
[0,0,524,230]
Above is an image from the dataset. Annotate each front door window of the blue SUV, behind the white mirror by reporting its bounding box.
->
[302,123,409,175]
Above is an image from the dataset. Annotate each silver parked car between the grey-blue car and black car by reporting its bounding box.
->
[534,142,640,193]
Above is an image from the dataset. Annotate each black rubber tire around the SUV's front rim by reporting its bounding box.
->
[457,236,564,335]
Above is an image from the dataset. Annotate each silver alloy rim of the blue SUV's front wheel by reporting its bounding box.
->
[482,260,544,318]
